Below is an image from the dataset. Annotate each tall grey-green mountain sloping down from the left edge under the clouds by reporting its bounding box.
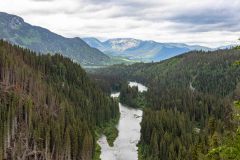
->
[0,12,110,65]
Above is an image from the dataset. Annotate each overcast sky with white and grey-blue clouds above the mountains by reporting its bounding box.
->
[0,0,240,47]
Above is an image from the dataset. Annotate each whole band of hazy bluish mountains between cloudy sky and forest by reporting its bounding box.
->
[0,12,232,66]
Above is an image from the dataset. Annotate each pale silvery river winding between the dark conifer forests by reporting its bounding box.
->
[98,82,147,160]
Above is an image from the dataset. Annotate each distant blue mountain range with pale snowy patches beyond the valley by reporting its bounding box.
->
[83,38,210,62]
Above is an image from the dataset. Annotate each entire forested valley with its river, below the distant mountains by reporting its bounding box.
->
[0,37,240,160]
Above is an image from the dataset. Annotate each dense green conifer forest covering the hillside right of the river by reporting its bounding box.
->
[92,48,240,160]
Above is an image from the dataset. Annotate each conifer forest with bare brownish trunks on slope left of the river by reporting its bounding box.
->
[0,41,119,160]
